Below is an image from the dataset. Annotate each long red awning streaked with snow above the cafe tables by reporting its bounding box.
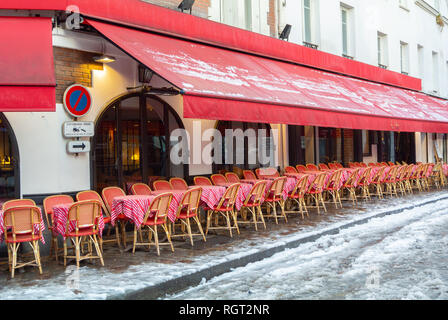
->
[88,20,448,132]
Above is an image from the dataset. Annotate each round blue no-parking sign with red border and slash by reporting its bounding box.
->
[63,84,92,117]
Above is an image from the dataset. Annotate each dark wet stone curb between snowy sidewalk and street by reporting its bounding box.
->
[107,195,448,300]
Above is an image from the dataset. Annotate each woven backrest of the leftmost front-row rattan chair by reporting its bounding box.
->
[3,205,41,240]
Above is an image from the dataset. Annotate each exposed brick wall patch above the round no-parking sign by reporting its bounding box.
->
[53,47,103,103]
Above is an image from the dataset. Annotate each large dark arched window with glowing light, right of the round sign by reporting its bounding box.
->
[92,93,186,191]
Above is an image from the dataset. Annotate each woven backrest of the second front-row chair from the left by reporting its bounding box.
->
[65,200,101,233]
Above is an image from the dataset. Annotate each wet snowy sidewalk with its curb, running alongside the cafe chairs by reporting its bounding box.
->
[0,190,448,300]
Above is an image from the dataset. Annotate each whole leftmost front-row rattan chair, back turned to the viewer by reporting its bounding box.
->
[3,205,42,278]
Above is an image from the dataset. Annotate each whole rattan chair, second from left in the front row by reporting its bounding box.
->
[64,200,104,268]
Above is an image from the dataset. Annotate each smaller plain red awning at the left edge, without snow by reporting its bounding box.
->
[0,17,56,111]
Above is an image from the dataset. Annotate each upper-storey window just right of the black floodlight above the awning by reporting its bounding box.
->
[303,0,319,49]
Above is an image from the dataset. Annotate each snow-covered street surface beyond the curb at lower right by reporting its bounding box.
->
[166,195,448,300]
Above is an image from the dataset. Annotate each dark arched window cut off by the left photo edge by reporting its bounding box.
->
[0,113,20,202]
